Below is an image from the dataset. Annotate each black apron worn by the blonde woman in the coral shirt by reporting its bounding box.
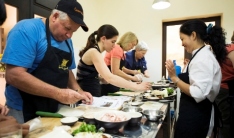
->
[101,53,125,95]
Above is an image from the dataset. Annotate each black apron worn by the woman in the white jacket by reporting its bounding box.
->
[174,46,212,138]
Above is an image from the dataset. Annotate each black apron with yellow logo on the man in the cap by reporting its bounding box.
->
[19,19,72,121]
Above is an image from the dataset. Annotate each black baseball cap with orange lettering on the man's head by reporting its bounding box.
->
[55,0,89,32]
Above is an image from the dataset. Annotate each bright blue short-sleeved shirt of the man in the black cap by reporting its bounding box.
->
[2,18,76,110]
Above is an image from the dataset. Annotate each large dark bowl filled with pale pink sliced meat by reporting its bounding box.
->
[94,110,131,133]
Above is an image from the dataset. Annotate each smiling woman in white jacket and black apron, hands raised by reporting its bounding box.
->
[165,19,227,138]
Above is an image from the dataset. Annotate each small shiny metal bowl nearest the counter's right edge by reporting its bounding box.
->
[142,110,163,121]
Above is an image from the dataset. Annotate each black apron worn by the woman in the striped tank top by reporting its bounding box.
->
[77,46,101,97]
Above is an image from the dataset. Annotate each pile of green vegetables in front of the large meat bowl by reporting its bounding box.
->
[72,122,97,136]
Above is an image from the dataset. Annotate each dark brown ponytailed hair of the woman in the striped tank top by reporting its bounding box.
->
[79,24,119,57]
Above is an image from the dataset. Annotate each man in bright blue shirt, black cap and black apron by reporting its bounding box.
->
[2,0,93,123]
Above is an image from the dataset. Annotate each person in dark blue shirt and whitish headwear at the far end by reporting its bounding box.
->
[123,41,149,78]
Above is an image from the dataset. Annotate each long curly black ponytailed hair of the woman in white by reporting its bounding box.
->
[180,19,227,63]
